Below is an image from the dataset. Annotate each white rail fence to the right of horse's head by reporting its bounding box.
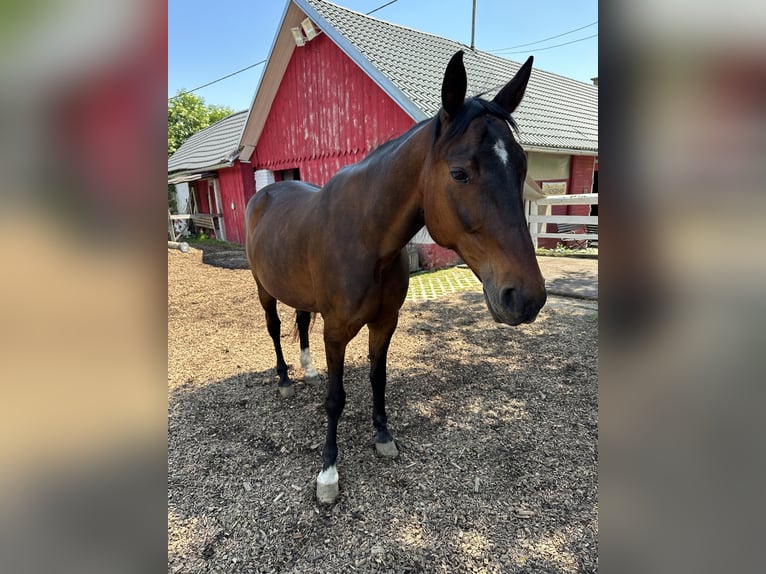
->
[524,193,598,248]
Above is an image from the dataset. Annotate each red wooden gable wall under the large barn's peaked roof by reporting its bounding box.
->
[253,35,414,185]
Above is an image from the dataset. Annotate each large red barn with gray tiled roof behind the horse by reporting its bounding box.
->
[171,0,598,267]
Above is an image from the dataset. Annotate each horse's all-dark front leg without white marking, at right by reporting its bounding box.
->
[368,313,399,458]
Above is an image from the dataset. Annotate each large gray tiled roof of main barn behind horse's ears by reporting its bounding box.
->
[294,0,598,152]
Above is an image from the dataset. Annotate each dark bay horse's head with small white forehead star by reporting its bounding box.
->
[423,52,546,325]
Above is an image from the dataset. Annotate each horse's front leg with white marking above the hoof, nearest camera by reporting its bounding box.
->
[317,328,348,504]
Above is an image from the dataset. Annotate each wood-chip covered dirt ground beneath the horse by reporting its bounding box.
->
[168,249,598,573]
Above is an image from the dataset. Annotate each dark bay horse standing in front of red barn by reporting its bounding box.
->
[246,52,546,503]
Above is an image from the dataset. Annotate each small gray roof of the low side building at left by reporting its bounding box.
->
[168,110,247,173]
